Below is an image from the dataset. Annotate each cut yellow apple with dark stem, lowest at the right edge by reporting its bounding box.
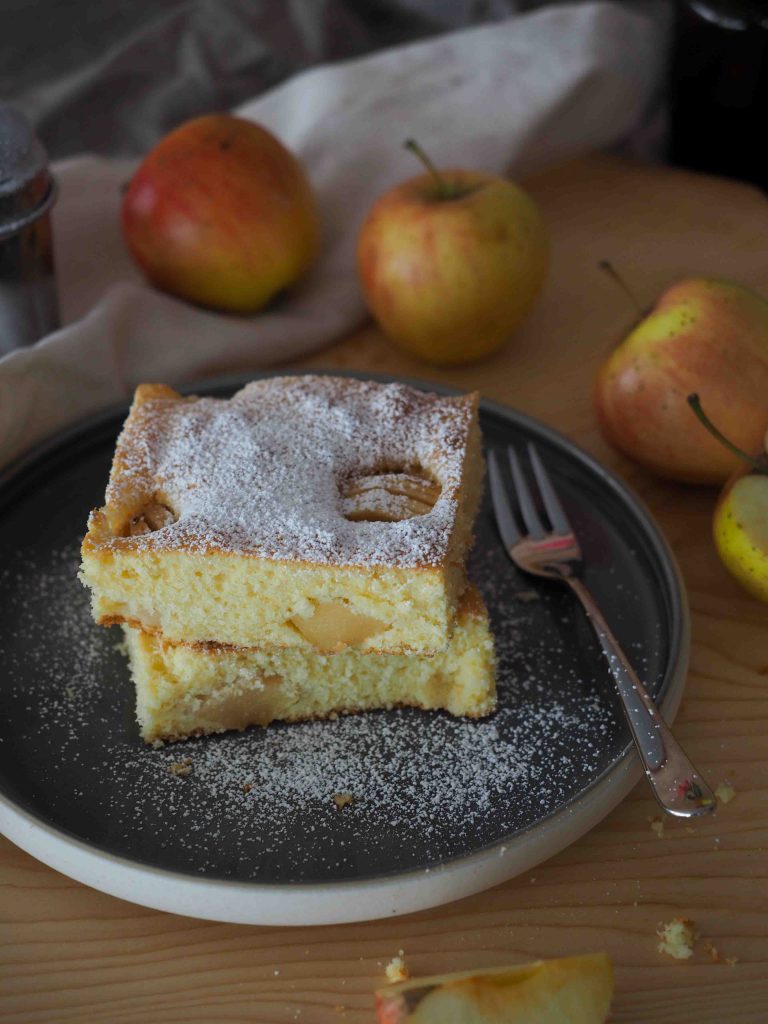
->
[688,394,768,601]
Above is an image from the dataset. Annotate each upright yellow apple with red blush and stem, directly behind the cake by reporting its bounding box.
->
[357,141,549,365]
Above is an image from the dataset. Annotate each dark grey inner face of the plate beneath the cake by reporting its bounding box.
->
[0,381,686,916]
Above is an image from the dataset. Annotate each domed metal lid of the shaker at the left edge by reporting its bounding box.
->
[0,103,55,238]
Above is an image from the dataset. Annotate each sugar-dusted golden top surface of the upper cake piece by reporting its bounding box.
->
[99,376,475,567]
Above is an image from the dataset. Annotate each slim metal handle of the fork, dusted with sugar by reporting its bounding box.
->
[564,575,717,818]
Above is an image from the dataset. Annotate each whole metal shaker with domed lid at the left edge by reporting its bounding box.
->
[0,103,58,356]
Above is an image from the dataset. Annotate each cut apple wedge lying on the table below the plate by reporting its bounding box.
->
[376,953,613,1024]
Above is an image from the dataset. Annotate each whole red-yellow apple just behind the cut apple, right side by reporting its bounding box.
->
[595,278,768,483]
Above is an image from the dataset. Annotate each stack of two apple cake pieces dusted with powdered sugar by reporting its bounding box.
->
[81,376,495,741]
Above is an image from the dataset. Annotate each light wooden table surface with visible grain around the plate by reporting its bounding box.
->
[0,157,768,1024]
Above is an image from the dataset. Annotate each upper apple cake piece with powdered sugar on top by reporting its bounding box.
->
[81,376,483,654]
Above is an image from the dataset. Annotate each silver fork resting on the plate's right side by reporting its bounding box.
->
[488,444,717,818]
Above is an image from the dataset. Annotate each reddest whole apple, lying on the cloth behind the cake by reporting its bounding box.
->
[123,114,319,313]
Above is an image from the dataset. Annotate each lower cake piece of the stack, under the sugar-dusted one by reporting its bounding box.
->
[125,588,496,742]
